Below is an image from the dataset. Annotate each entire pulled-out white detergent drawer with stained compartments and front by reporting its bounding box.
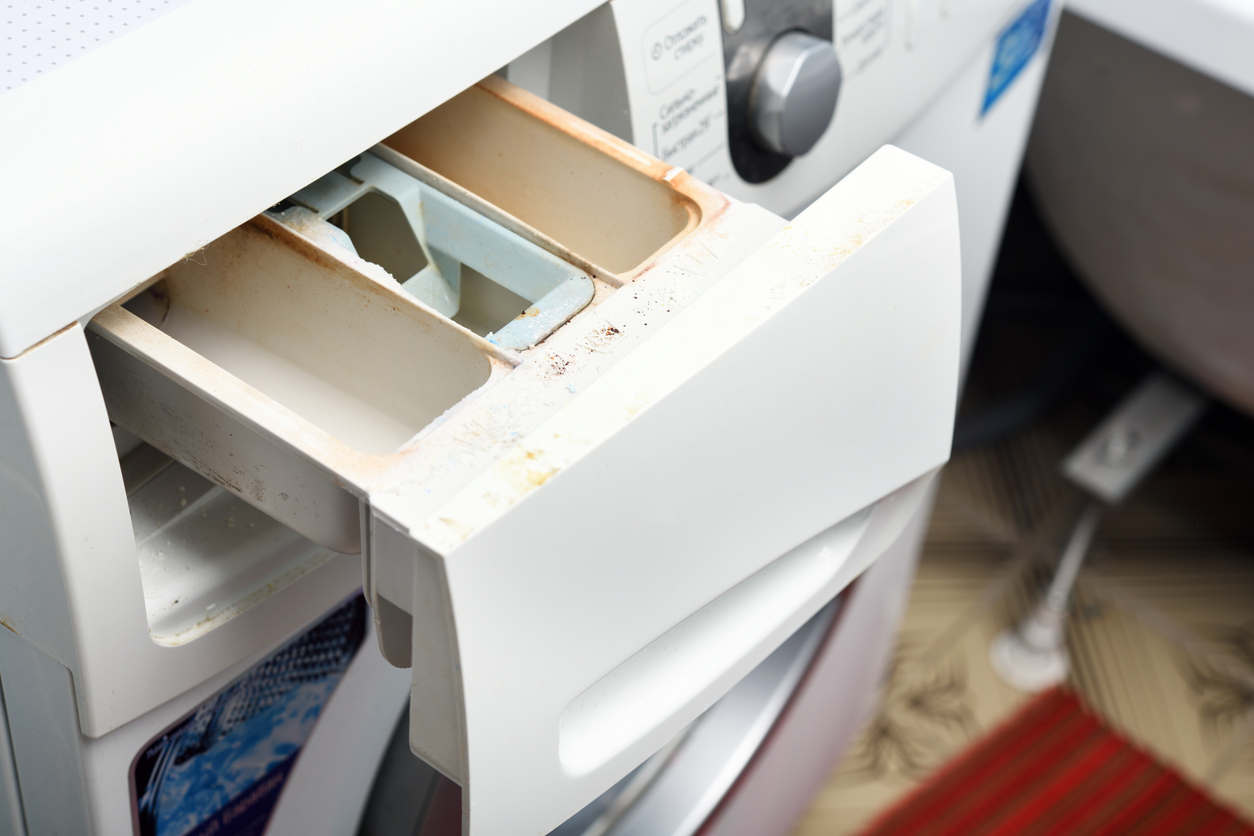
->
[92,79,959,833]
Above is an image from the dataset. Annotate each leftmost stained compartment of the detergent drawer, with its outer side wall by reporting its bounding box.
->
[90,217,508,554]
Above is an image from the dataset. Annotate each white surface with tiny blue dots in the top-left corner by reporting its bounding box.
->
[0,0,191,95]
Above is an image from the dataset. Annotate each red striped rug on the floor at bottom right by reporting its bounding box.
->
[863,689,1254,836]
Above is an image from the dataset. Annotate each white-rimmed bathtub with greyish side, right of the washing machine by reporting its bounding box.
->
[1028,0,1254,412]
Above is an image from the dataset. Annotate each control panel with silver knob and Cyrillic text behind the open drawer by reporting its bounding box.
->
[519,0,1056,217]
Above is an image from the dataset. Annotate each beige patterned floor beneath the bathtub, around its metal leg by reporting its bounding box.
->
[794,184,1254,836]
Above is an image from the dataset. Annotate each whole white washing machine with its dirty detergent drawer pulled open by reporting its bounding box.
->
[0,0,1056,836]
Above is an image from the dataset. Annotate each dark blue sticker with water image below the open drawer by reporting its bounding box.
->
[130,594,366,836]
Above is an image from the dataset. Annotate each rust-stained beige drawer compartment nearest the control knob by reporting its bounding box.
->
[382,76,725,278]
